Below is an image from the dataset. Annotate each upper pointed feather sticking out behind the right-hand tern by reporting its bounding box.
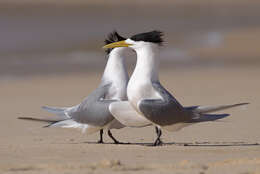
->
[192,103,249,114]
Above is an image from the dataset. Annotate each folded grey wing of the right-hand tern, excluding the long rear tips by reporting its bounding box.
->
[138,82,192,126]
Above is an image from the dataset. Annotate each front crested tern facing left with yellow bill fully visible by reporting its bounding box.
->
[103,31,248,146]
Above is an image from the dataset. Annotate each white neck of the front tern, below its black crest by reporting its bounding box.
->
[133,45,159,82]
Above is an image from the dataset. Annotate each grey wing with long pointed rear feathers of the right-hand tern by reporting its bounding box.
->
[138,82,249,126]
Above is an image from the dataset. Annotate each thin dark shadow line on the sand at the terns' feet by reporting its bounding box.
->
[71,141,260,147]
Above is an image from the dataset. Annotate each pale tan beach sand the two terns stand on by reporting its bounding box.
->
[0,66,260,174]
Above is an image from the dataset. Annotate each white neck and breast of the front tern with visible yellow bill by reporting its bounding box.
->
[127,43,161,110]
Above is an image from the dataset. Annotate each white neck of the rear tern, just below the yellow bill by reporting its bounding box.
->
[102,49,128,83]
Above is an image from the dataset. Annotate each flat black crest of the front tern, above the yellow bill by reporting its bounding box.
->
[130,30,163,45]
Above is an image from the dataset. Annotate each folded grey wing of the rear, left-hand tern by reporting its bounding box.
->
[69,85,115,127]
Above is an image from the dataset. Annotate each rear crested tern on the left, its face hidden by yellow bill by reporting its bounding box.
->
[19,31,129,144]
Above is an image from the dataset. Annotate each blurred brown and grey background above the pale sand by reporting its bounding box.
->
[0,0,260,77]
